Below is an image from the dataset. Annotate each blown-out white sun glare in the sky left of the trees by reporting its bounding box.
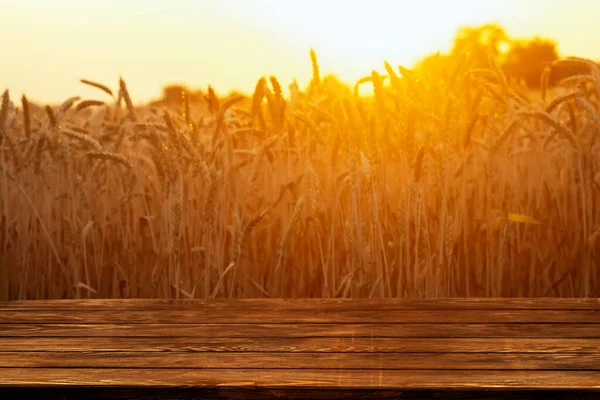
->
[225,0,508,85]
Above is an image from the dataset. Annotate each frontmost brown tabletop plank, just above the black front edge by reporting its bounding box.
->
[0,368,600,390]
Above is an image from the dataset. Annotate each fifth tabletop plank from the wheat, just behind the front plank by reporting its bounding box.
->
[0,351,600,372]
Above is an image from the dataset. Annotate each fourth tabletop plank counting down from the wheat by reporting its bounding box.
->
[0,337,600,354]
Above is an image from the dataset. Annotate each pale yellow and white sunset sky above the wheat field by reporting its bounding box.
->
[0,0,600,104]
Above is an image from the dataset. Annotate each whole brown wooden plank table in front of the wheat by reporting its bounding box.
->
[0,299,600,400]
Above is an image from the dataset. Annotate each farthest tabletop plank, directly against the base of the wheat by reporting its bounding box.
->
[0,298,600,313]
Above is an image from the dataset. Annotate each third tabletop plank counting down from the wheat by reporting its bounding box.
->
[0,323,600,338]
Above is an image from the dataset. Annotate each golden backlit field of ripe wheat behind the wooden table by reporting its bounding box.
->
[0,52,600,300]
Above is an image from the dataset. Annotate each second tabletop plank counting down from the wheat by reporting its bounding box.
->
[0,308,600,324]
